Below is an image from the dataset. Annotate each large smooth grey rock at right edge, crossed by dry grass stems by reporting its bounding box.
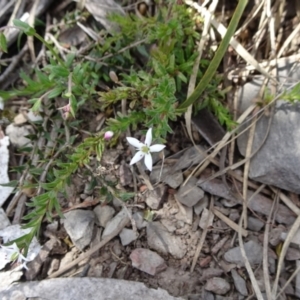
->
[238,61,300,194]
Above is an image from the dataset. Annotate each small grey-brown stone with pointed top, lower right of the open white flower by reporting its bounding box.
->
[176,177,204,207]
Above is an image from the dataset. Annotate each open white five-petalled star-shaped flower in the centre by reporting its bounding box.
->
[127,128,166,171]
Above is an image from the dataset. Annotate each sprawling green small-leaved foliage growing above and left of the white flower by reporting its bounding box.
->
[0,3,239,253]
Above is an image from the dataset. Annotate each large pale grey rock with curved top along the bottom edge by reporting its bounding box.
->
[0,277,183,300]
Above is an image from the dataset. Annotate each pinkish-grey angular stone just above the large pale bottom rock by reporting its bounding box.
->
[130,248,167,275]
